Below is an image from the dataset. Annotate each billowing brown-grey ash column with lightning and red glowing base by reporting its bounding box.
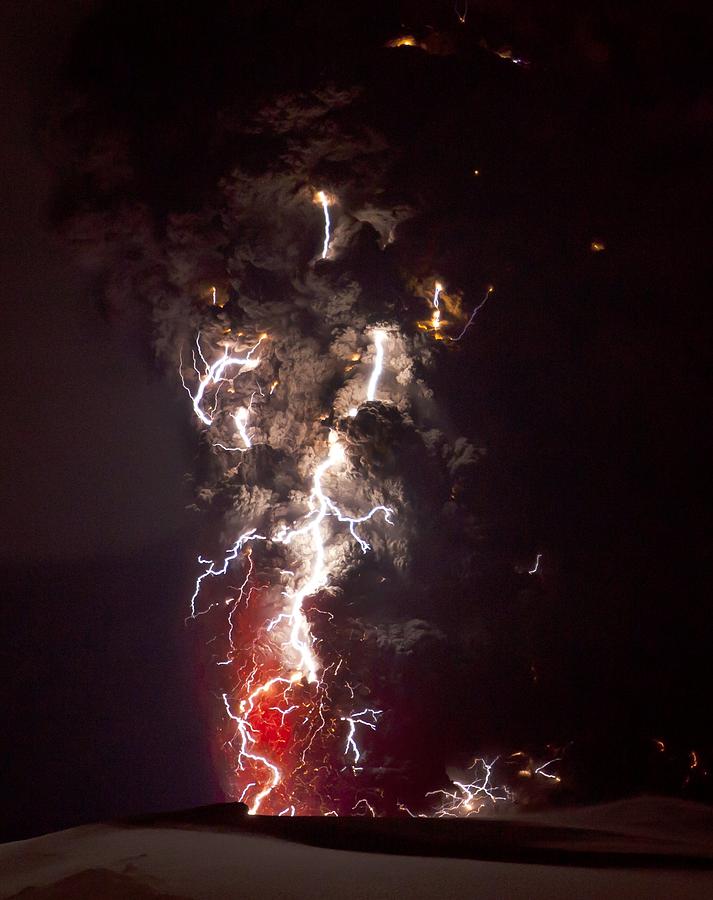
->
[57,17,496,814]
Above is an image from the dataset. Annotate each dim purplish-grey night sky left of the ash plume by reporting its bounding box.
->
[0,3,214,838]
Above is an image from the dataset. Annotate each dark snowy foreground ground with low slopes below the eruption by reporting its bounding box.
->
[0,798,713,900]
